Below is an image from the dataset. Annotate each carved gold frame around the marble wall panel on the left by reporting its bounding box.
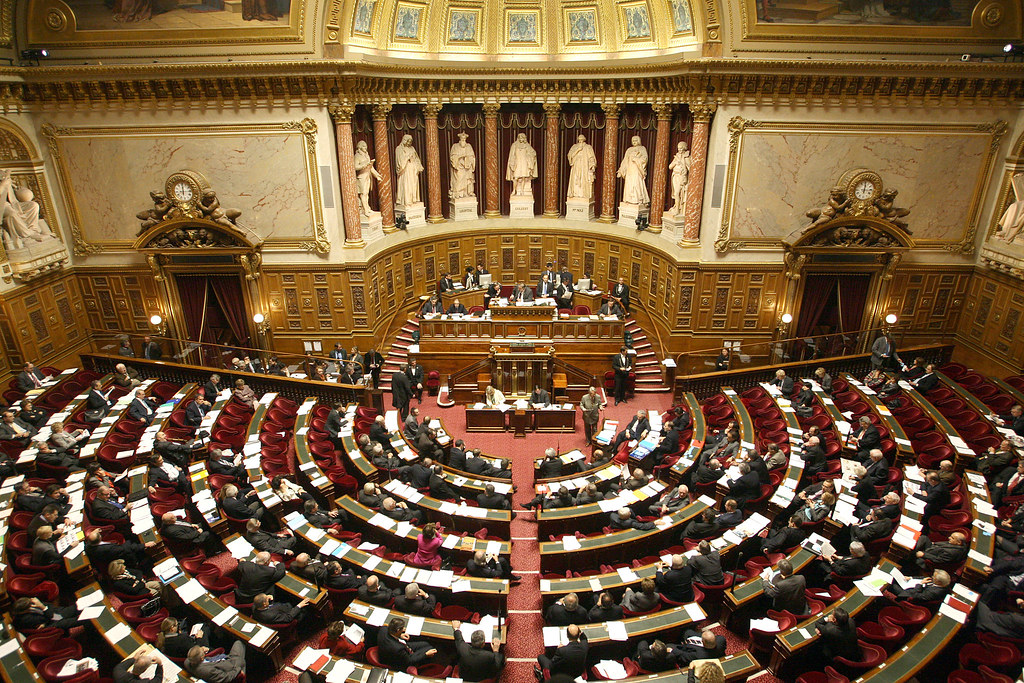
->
[42,119,331,256]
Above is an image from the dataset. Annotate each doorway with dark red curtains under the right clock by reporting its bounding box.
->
[794,272,872,359]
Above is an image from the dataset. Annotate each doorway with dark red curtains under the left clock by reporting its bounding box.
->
[174,273,250,368]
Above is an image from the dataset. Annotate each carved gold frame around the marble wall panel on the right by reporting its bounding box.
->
[715,116,1008,255]
